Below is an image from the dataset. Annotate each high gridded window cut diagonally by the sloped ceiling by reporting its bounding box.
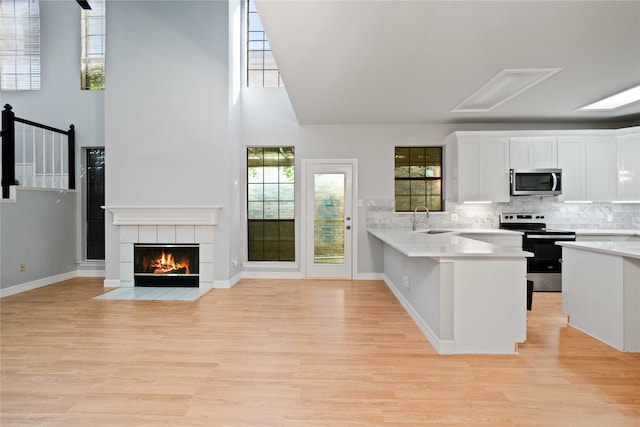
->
[247,0,284,87]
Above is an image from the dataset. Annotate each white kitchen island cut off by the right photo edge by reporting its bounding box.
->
[558,241,640,352]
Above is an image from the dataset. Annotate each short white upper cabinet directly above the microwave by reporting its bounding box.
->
[509,137,558,169]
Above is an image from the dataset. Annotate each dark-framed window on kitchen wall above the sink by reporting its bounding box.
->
[395,147,443,212]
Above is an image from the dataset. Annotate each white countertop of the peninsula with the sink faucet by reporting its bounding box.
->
[367,229,533,258]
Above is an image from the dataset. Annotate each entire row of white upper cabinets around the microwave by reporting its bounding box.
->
[445,127,640,202]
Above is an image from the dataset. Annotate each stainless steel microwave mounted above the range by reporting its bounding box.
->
[511,169,562,196]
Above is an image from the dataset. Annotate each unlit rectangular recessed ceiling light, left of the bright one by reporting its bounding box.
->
[451,68,561,113]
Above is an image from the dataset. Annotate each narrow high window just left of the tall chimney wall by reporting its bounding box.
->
[80,0,105,90]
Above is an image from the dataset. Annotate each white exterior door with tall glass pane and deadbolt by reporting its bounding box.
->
[305,163,353,278]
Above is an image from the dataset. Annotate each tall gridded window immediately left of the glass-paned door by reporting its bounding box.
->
[247,147,295,261]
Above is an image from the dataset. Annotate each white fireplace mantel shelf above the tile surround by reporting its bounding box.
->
[102,206,222,225]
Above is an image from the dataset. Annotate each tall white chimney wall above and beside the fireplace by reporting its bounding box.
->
[105,1,235,279]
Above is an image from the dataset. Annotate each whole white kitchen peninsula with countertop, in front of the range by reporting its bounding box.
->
[368,229,532,354]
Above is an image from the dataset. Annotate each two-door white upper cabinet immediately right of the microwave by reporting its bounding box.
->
[558,136,616,201]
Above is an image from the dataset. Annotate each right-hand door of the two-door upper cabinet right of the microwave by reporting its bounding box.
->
[585,137,616,201]
